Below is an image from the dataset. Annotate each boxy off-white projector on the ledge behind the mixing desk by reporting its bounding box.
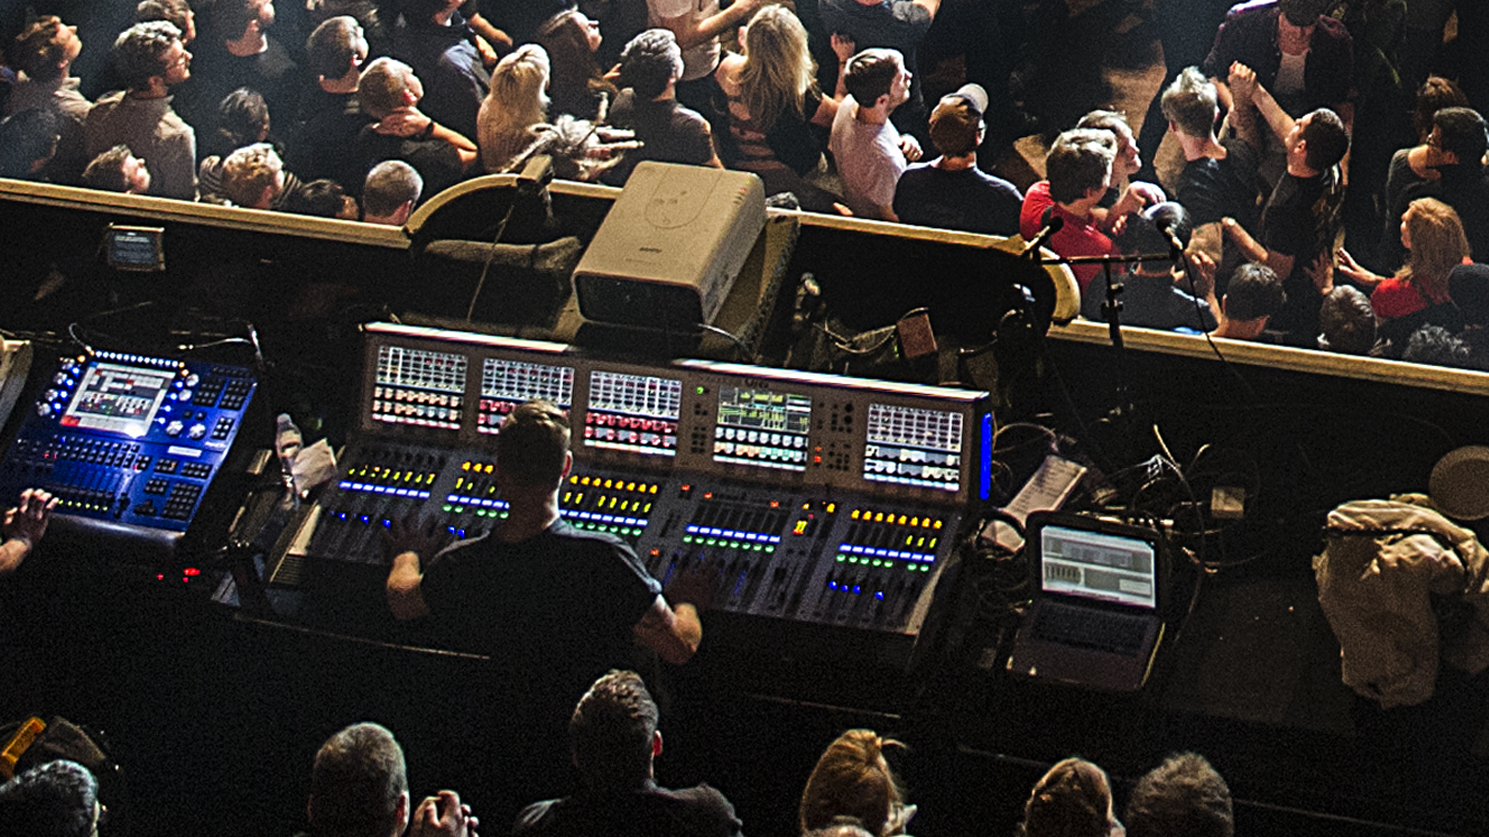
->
[573,161,765,328]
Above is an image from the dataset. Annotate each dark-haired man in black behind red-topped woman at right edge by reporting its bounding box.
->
[1379,107,1489,265]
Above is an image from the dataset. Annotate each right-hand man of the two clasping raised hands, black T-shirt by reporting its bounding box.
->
[1224,66,1349,347]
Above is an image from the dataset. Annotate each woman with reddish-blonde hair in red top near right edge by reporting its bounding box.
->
[1339,198,1468,354]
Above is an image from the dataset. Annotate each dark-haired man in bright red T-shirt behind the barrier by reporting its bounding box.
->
[1018,128,1117,298]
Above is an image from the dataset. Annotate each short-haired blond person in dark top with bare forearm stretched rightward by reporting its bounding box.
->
[357,58,476,194]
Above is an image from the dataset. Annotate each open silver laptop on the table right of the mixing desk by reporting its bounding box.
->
[1008,512,1164,691]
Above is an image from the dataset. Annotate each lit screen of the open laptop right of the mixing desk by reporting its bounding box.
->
[1039,526,1158,609]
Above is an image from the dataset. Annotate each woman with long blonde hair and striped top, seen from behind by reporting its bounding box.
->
[713,4,837,211]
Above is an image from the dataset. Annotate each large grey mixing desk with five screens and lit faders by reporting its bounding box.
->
[270,323,993,649]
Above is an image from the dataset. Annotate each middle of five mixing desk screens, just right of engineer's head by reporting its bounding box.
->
[584,371,682,456]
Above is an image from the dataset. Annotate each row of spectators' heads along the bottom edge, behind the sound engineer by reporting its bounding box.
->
[0,670,1234,837]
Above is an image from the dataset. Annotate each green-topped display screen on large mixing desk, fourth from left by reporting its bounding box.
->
[713,387,812,471]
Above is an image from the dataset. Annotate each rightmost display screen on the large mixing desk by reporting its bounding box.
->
[864,404,965,491]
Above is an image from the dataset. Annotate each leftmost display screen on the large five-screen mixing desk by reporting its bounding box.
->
[372,346,468,430]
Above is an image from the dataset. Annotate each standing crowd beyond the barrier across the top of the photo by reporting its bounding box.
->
[0,0,1489,361]
